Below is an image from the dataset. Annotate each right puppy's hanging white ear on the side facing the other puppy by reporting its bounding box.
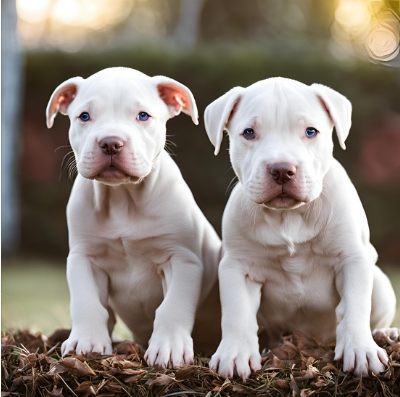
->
[204,87,244,155]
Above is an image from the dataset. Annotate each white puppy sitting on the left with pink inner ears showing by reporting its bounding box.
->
[47,68,221,367]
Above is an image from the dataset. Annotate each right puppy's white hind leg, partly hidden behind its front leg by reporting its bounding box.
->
[371,266,400,341]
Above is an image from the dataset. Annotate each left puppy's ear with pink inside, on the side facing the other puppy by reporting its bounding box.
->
[153,76,199,125]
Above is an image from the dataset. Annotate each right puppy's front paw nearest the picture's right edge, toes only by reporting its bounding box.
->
[335,337,388,376]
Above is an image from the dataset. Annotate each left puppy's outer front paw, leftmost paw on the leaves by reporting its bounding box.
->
[61,332,112,356]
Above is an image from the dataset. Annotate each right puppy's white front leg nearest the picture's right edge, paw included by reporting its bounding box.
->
[335,247,388,376]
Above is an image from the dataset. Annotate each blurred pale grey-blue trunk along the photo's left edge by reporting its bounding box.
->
[1,0,22,254]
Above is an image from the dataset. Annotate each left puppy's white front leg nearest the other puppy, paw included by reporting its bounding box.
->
[145,251,203,368]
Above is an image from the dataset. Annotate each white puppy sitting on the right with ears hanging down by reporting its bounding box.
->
[205,78,398,379]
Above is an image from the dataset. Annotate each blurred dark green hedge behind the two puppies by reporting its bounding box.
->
[21,44,400,262]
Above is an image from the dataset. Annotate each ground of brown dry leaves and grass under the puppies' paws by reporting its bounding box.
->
[1,330,400,397]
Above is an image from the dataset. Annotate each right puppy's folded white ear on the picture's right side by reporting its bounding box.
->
[311,84,351,149]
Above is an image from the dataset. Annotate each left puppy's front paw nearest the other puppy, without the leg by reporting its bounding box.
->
[144,333,194,369]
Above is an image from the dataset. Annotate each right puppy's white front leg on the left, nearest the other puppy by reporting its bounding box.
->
[210,257,261,380]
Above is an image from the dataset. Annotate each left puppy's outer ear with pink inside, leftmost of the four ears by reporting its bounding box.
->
[46,77,83,128]
